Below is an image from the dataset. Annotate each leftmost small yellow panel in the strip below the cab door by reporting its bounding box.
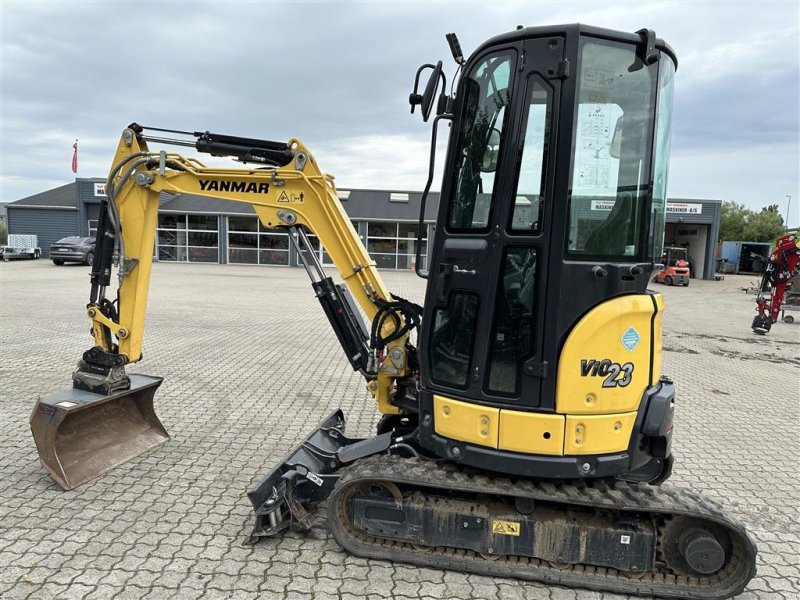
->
[433,395,500,448]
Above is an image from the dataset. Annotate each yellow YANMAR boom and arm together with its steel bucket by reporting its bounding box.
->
[31,124,422,489]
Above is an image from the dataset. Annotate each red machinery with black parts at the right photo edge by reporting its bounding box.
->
[752,234,800,335]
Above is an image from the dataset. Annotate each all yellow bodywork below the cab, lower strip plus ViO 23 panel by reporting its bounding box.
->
[434,294,664,456]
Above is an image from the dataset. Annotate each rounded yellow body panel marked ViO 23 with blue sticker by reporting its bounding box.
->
[556,294,661,415]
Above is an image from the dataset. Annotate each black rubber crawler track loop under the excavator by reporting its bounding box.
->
[328,455,756,600]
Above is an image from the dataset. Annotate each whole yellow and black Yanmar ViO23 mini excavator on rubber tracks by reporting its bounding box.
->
[31,25,756,599]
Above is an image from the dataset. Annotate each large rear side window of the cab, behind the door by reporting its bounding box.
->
[567,38,669,260]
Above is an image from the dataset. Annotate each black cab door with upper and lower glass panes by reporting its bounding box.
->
[420,37,564,408]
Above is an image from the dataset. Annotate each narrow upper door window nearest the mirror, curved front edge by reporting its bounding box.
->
[447,51,514,231]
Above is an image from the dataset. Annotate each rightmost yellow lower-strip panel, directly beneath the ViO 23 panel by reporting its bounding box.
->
[564,411,636,455]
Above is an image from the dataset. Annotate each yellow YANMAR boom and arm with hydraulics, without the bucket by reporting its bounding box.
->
[84,124,413,414]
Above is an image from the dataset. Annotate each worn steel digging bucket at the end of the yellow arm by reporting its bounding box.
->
[31,375,169,490]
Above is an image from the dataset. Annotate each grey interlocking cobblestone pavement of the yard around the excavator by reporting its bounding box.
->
[0,260,800,600]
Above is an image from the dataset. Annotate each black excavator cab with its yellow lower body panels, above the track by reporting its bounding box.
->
[412,26,676,480]
